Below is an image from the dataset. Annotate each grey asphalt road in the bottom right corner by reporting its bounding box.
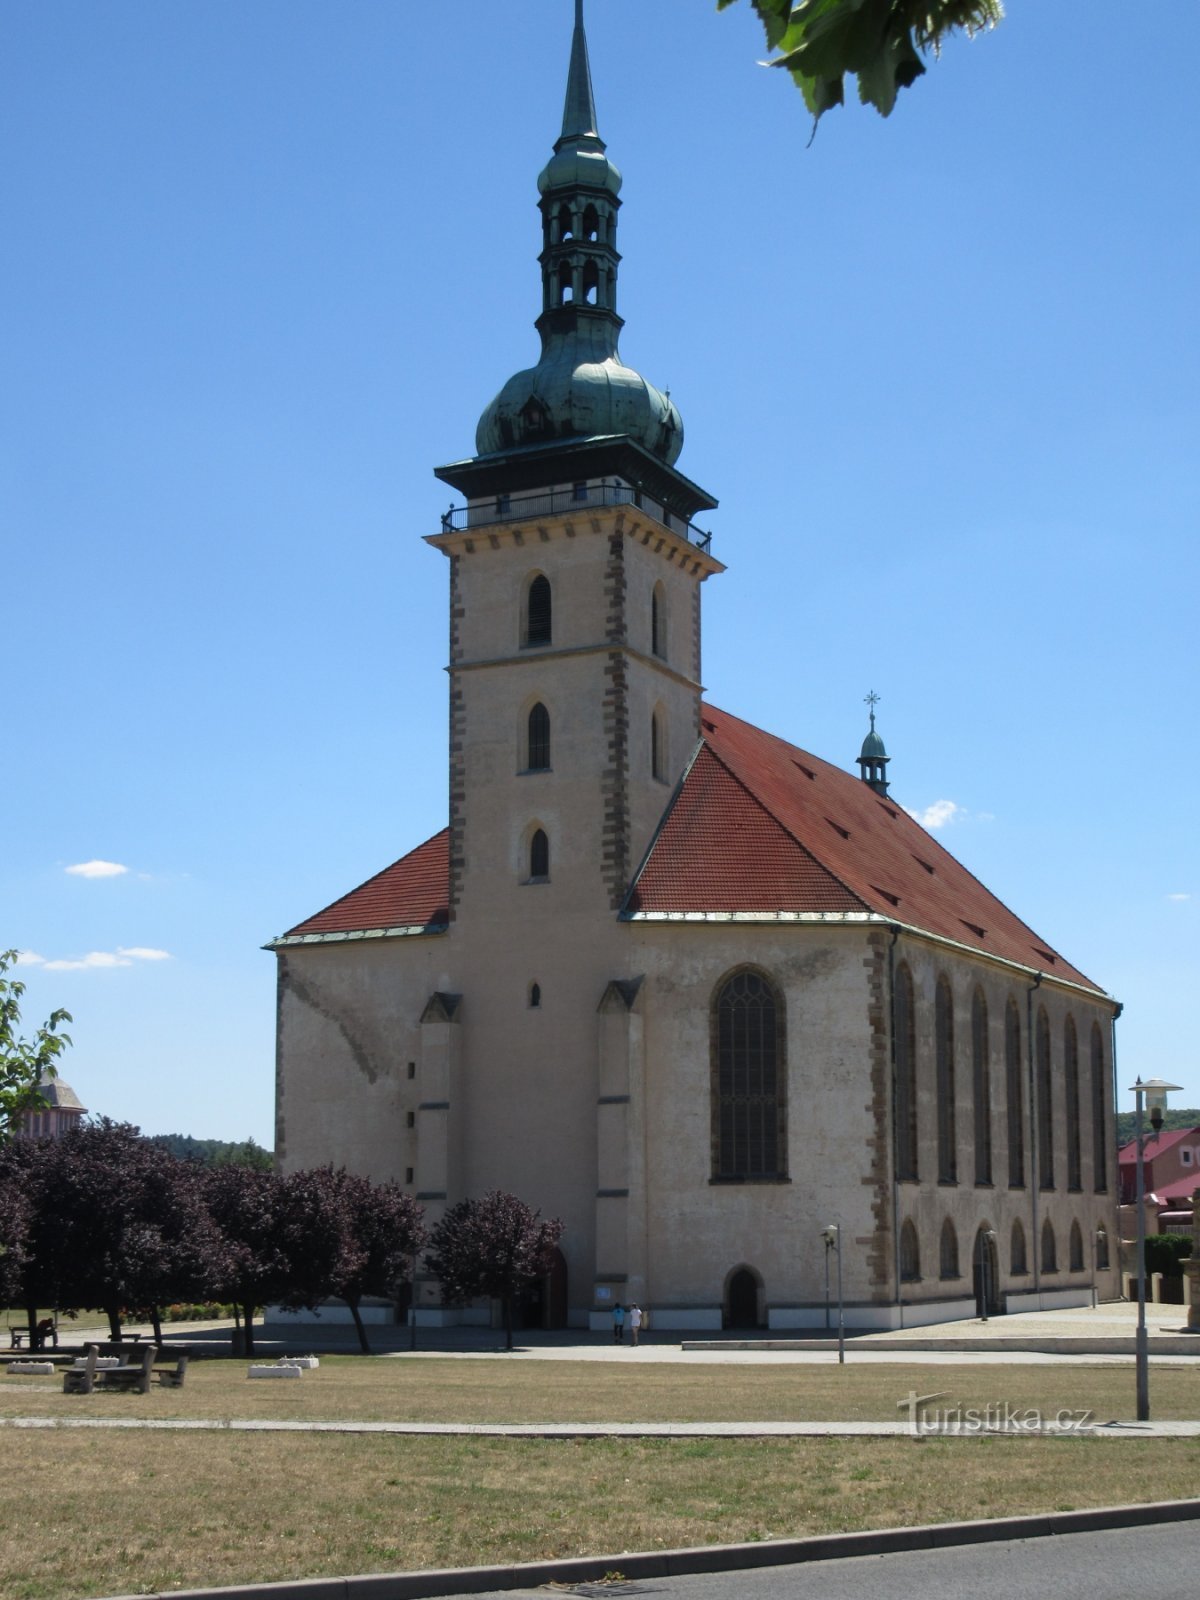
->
[438,1522,1200,1600]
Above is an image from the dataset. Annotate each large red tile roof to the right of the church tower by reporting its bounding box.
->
[626,704,1102,994]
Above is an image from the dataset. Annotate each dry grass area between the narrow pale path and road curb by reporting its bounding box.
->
[0,1429,1200,1600]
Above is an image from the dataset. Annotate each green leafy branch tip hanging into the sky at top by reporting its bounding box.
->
[717,0,1005,122]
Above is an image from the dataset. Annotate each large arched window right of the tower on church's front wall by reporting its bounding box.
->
[712,968,787,1182]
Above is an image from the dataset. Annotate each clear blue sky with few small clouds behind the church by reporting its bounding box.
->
[0,0,1200,1144]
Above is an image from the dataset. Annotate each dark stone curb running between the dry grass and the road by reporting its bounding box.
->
[91,1499,1200,1600]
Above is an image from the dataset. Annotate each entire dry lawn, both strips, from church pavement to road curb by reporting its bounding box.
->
[0,1357,1200,1600]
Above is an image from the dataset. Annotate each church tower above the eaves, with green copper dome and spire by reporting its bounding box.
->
[429,0,723,918]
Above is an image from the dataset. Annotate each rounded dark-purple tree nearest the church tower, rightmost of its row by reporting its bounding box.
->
[426,1189,563,1350]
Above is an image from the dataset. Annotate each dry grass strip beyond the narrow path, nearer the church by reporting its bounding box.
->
[0,1357,1197,1422]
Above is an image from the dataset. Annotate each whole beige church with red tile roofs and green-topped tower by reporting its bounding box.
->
[269,0,1120,1330]
